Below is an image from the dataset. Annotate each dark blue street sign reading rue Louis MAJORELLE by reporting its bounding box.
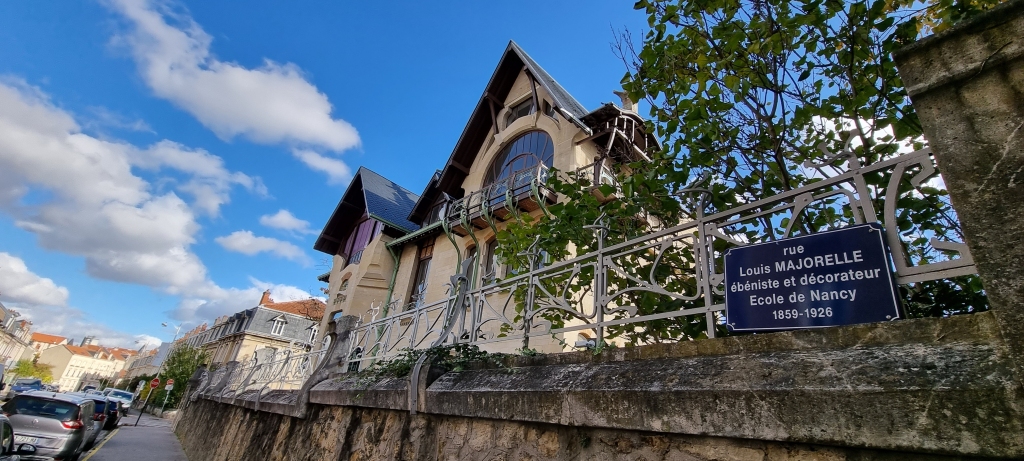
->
[725,223,900,331]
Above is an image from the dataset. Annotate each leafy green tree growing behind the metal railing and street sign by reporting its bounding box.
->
[499,0,992,343]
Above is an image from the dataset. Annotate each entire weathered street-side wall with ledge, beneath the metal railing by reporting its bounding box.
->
[178,312,1024,461]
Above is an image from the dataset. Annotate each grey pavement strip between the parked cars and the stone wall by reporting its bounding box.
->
[82,413,187,461]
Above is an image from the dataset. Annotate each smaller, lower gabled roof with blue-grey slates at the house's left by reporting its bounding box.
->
[313,167,420,255]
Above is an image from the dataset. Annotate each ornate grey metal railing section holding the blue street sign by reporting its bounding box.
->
[349,141,976,370]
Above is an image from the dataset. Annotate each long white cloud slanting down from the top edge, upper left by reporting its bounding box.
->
[109,0,359,152]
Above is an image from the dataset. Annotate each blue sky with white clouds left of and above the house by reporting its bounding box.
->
[0,0,646,346]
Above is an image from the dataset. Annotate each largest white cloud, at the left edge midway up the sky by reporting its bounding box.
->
[0,79,265,296]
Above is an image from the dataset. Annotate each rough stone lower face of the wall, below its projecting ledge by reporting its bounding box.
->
[178,401,978,461]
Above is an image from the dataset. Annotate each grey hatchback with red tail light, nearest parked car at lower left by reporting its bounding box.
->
[2,390,98,461]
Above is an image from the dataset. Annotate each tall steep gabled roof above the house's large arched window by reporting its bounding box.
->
[409,41,590,222]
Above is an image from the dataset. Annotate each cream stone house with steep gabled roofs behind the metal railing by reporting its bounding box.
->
[314,42,655,351]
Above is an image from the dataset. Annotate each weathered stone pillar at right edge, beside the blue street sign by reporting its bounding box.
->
[894,0,1024,385]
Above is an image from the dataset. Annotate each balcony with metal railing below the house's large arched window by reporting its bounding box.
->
[442,165,555,236]
